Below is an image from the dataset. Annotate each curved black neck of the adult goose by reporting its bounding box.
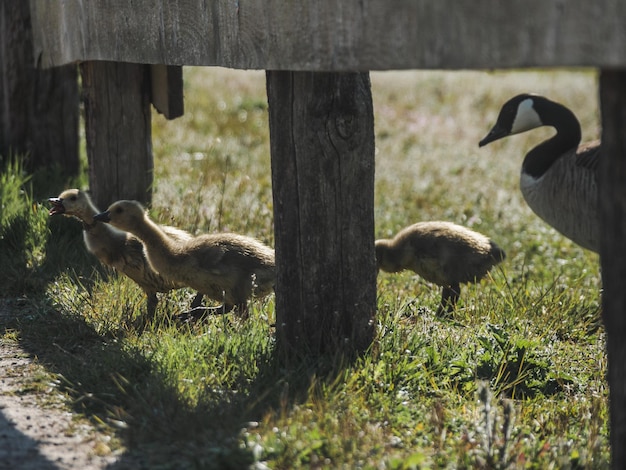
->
[522,98,581,178]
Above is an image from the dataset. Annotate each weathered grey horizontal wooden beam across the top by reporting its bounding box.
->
[30,0,626,71]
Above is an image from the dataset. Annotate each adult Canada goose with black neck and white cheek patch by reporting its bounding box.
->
[478,94,600,253]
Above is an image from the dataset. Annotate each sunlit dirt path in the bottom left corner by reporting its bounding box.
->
[0,301,130,470]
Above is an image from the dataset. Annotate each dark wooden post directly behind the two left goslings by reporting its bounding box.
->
[81,62,154,209]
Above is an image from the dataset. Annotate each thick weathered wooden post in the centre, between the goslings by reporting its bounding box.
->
[267,71,376,357]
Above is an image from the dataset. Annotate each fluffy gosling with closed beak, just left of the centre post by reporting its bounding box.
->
[95,201,276,318]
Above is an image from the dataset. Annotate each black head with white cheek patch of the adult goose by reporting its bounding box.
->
[478,93,545,147]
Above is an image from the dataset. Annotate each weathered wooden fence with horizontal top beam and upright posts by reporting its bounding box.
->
[30,0,626,469]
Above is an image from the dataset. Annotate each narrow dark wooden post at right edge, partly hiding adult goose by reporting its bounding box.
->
[599,69,626,470]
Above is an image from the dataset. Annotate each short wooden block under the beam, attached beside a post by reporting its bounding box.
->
[150,64,185,119]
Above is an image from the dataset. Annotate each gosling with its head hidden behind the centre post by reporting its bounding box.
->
[376,221,506,315]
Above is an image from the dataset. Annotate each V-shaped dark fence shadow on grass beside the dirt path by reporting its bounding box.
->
[0,299,356,469]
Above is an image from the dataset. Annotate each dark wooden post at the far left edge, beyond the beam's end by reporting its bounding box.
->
[0,0,79,176]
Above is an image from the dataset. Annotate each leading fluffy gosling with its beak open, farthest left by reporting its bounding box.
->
[48,189,202,317]
